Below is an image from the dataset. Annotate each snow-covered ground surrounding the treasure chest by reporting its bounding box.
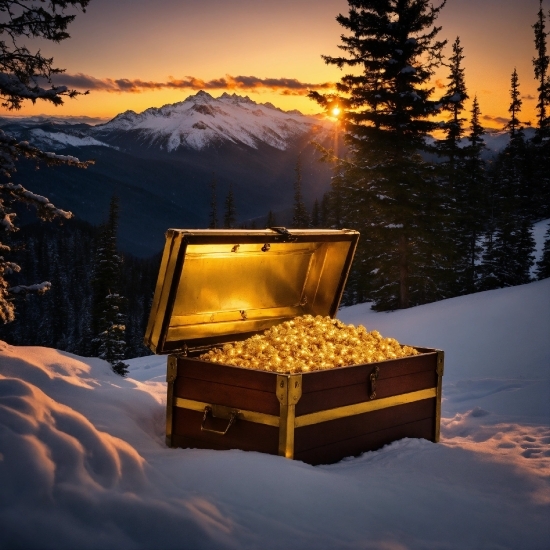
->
[0,279,550,550]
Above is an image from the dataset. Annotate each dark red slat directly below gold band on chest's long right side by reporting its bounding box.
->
[294,399,435,452]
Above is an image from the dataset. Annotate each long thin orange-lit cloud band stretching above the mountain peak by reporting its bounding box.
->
[54,73,334,95]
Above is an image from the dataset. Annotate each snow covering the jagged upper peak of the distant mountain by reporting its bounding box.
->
[91,91,333,152]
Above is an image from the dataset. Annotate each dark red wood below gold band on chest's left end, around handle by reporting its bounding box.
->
[172,407,279,454]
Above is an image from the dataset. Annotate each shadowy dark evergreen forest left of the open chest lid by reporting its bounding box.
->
[0,213,160,366]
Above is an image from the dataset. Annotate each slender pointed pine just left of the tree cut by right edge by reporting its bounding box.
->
[480,69,535,290]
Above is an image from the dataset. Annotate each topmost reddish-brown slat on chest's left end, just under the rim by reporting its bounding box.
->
[178,357,277,392]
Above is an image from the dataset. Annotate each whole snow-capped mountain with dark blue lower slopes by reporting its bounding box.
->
[0,91,336,256]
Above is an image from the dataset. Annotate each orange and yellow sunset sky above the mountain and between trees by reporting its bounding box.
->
[0,0,550,127]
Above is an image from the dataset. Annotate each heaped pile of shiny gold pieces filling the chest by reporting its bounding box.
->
[200,315,418,373]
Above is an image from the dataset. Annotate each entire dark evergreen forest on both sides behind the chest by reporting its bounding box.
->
[0,0,550,366]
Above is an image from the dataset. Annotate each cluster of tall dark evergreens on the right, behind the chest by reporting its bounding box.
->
[309,0,550,311]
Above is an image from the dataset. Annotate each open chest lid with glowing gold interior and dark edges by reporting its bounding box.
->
[145,228,359,353]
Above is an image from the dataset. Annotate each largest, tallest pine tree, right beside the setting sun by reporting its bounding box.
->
[310,0,445,310]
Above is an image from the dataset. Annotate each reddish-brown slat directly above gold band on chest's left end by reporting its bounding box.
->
[174,376,280,416]
